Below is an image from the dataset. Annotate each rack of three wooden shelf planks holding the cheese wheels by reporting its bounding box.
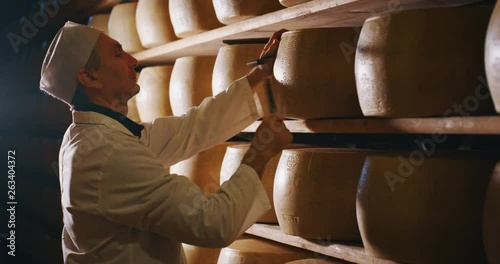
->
[133,0,500,263]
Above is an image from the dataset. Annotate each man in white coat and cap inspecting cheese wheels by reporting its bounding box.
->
[40,22,292,264]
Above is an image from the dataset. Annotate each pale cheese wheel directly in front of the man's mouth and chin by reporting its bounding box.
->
[135,65,174,122]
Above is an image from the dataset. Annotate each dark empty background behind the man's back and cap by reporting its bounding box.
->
[0,0,120,264]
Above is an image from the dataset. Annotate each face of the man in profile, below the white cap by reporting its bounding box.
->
[97,34,140,103]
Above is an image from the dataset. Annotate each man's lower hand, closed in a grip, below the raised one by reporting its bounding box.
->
[241,114,293,177]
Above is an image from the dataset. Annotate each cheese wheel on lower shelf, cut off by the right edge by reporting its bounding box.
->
[483,163,500,263]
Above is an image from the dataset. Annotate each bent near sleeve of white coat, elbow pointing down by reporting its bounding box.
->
[98,142,271,247]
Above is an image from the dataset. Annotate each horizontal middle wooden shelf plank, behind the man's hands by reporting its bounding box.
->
[243,116,500,135]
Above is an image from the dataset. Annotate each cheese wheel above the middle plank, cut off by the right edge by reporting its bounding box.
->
[484,2,500,113]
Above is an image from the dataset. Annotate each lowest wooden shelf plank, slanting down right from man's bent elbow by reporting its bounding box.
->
[246,224,396,264]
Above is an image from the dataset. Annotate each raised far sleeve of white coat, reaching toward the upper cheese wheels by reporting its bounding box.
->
[141,77,262,166]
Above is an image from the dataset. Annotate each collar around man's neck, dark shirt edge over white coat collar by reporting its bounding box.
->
[73,104,144,137]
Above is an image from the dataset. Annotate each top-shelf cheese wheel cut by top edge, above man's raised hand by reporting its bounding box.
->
[212,0,283,25]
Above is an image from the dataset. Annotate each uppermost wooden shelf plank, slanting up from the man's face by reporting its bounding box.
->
[133,0,481,66]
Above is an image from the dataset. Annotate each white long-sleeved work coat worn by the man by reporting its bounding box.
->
[59,78,271,264]
